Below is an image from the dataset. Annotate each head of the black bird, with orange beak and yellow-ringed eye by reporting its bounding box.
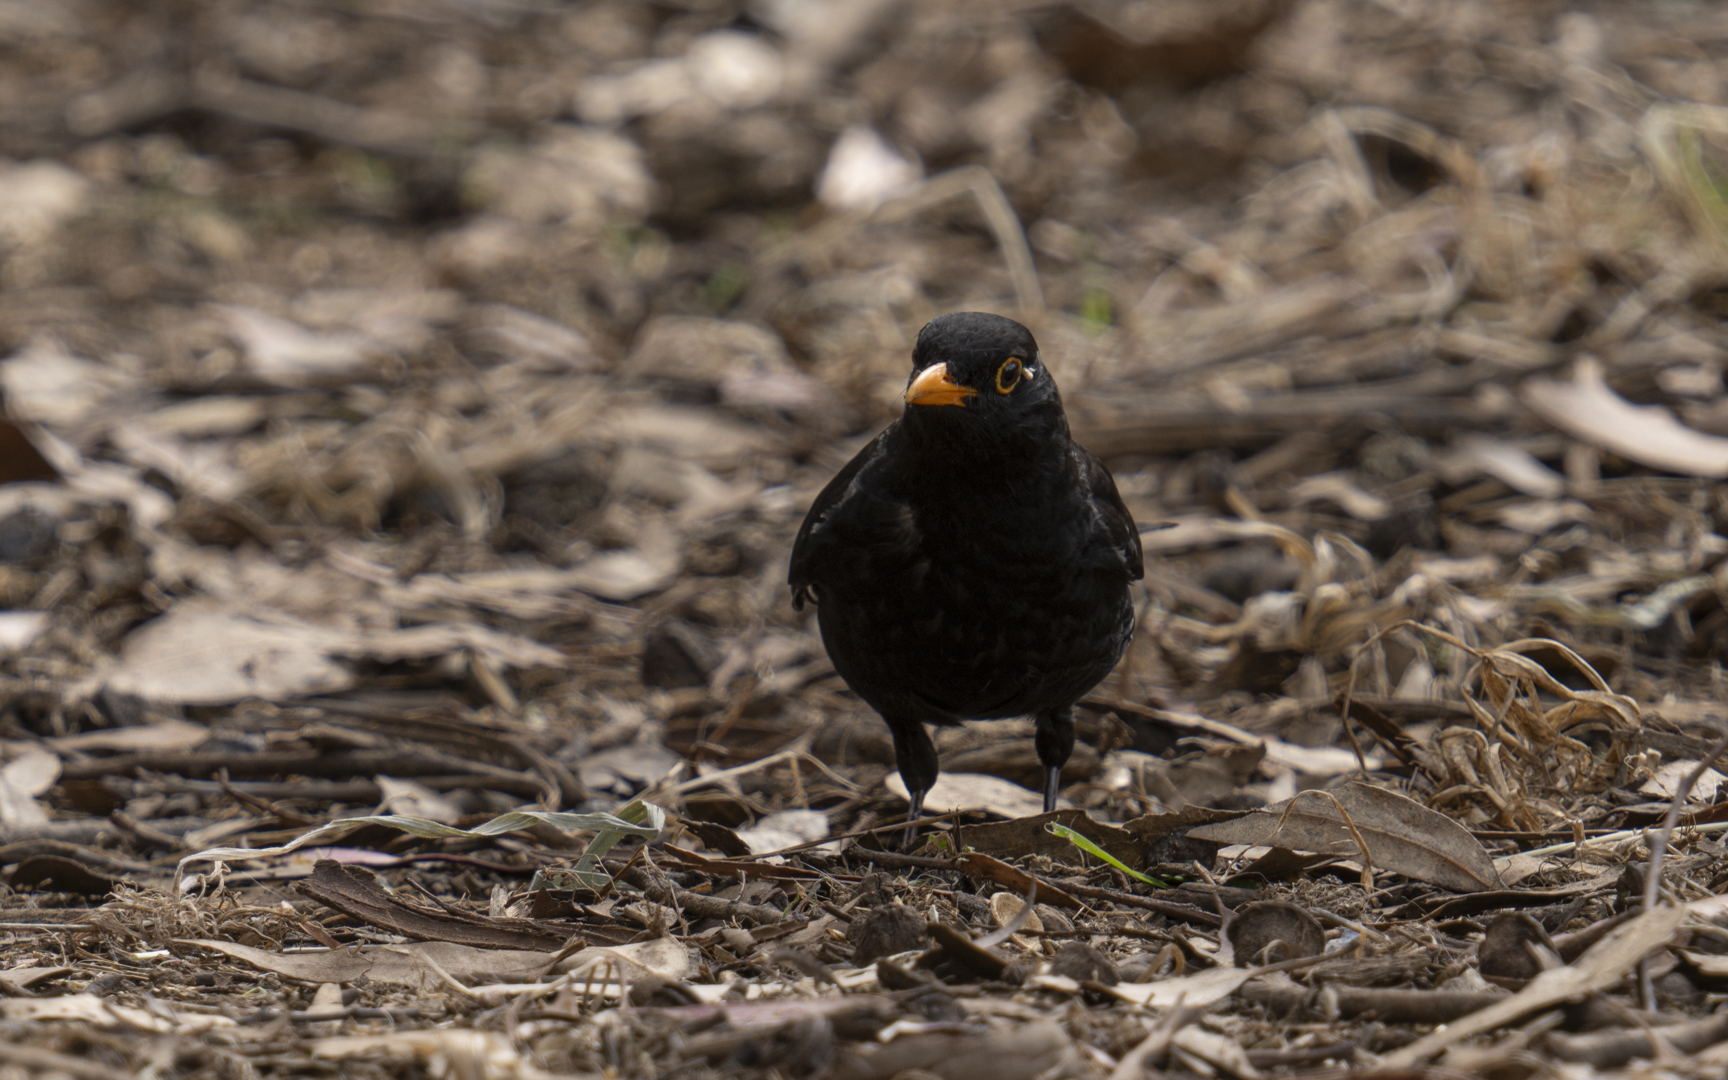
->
[905,311,1064,437]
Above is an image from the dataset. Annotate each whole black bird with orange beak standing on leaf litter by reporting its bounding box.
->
[790,311,1140,821]
